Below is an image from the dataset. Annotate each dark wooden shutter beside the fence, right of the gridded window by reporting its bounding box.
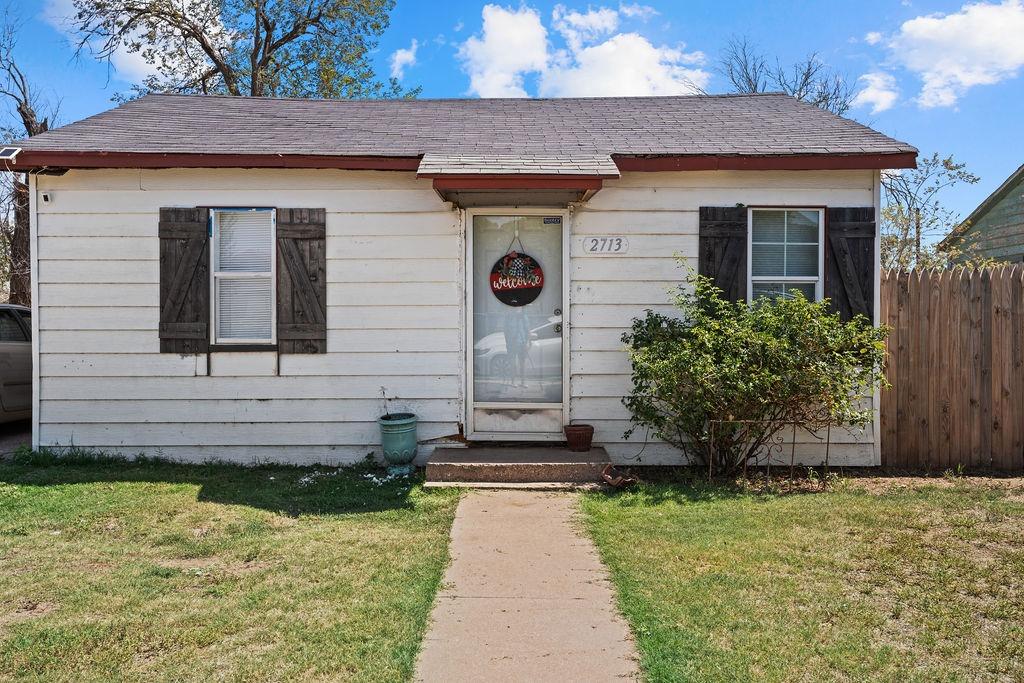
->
[824,207,878,324]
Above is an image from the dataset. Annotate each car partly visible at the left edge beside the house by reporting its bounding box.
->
[0,303,32,423]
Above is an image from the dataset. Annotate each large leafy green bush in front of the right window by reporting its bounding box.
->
[623,271,888,474]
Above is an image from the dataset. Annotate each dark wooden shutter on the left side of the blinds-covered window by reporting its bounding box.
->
[158,208,210,353]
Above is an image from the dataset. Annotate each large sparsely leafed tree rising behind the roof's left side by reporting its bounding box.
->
[71,0,419,98]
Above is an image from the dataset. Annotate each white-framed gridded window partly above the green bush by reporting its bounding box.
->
[748,209,823,301]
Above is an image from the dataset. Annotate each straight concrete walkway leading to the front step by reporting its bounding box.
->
[416,490,639,683]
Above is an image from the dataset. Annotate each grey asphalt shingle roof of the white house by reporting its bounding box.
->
[18,93,916,163]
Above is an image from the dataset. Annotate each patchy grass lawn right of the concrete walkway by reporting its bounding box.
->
[583,479,1024,683]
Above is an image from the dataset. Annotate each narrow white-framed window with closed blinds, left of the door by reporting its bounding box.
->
[210,209,276,344]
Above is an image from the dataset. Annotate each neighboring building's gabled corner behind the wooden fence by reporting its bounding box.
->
[939,166,1024,263]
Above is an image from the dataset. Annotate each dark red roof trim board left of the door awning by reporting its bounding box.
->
[11,150,420,171]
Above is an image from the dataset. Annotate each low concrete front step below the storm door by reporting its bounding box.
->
[427,446,611,485]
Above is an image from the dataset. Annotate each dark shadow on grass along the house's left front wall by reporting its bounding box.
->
[0,447,422,517]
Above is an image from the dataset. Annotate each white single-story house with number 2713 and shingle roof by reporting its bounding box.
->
[14,94,916,465]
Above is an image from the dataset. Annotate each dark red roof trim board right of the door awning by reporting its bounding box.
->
[611,152,918,171]
